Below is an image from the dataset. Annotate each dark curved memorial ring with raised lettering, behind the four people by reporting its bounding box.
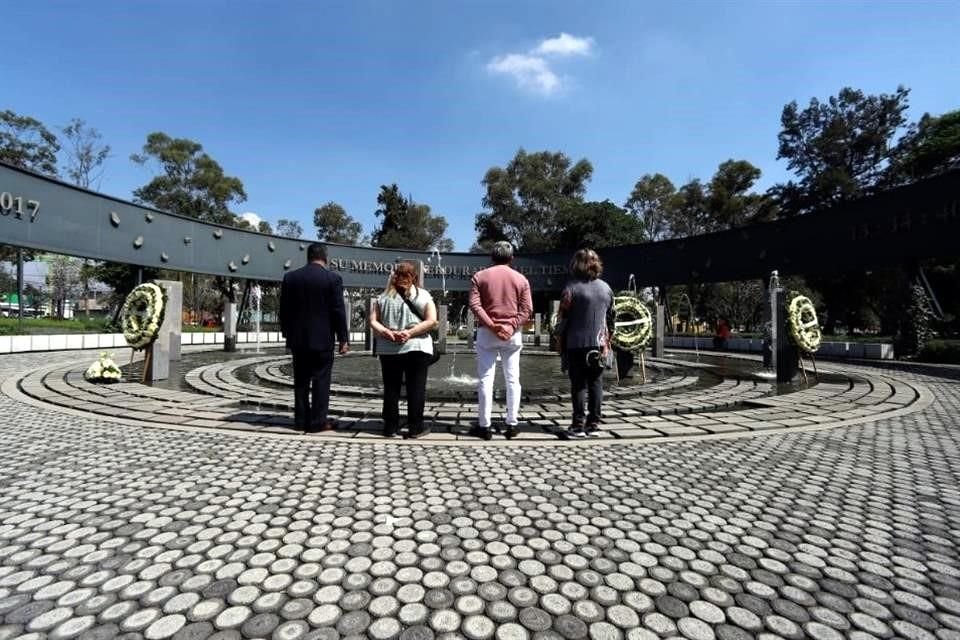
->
[0,163,960,291]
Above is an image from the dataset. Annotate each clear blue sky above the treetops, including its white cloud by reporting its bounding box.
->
[0,0,960,251]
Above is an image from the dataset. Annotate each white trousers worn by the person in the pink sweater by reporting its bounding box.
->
[477,327,523,428]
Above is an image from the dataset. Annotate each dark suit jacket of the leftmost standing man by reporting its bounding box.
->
[280,263,348,351]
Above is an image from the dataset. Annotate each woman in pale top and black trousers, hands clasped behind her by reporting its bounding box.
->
[370,262,437,438]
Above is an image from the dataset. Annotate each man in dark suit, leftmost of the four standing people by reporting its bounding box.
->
[280,244,350,433]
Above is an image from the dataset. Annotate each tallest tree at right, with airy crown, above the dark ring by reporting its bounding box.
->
[772,87,910,214]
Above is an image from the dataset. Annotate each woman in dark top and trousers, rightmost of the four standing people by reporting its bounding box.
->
[559,249,614,439]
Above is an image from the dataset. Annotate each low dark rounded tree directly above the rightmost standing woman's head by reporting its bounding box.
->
[554,200,644,251]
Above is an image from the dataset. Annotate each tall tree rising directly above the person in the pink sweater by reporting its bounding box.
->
[475,149,593,251]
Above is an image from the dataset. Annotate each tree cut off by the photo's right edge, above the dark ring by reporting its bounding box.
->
[885,109,960,185]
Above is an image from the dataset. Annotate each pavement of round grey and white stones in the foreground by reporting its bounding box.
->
[0,353,960,640]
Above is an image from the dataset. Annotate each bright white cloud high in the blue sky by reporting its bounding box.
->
[487,32,593,96]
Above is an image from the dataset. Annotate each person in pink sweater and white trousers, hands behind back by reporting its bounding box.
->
[470,242,533,440]
